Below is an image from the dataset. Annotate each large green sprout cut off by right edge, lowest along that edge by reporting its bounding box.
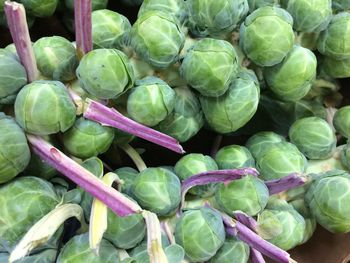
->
[305,170,350,233]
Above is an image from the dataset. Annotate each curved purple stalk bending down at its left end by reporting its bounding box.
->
[181,168,259,208]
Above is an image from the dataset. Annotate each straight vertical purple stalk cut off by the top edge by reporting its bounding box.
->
[74,0,92,58]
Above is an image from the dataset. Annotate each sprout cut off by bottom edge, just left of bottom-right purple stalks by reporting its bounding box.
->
[208,237,250,263]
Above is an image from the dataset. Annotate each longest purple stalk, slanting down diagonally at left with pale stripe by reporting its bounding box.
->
[27,134,142,216]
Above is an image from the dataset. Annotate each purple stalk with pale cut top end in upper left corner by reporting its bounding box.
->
[4,1,39,82]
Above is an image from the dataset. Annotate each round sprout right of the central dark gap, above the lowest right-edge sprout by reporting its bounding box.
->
[289,117,337,160]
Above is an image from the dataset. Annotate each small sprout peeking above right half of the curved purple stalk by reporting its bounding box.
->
[215,145,255,169]
